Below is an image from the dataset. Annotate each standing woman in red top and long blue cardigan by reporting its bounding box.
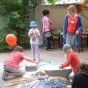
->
[63,5,82,49]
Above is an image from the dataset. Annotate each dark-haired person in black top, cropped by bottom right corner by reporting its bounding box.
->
[72,63,88,88]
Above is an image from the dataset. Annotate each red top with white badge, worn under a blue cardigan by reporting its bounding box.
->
[67,16,78,33]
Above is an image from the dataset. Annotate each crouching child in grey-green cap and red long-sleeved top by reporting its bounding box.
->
[60,44,80,79]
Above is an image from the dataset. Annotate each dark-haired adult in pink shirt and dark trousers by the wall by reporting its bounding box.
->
[42,10,52,50]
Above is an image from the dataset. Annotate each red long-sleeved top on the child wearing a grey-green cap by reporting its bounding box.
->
[62,51,80,73]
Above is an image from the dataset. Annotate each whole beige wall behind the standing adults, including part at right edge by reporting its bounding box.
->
[35,5,88,44]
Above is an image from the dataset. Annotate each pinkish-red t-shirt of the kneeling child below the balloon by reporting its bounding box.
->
[4,51,24,68]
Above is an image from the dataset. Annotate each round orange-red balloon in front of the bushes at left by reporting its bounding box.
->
[6,34,17,46]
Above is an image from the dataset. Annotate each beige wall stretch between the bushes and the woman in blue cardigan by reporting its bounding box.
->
[35,6,66,30]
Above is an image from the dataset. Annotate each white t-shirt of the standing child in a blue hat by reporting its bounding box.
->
[28,28,40,44]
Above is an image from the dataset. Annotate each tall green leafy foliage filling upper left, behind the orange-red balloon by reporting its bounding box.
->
[0,0,41,50]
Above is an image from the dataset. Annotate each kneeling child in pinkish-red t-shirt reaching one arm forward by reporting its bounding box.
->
[2,46,38,81]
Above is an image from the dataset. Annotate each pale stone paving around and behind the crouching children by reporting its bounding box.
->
[0,47,88,88]
